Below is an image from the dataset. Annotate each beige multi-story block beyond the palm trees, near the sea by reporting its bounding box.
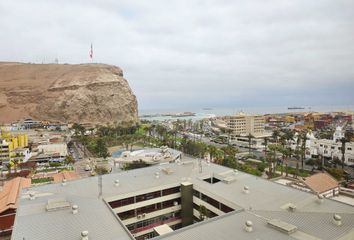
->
[226,113,265,140]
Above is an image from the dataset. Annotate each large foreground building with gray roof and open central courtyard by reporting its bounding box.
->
[11,160,354,240]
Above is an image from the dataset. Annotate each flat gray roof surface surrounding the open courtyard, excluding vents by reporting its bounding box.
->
[12,160,354,240]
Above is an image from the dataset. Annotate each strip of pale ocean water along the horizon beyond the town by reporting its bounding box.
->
[139,105,354,121]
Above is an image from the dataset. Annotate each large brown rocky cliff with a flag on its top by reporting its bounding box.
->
[0,62,138,124]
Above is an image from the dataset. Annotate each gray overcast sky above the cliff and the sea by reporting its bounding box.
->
[0,0,354,109]
